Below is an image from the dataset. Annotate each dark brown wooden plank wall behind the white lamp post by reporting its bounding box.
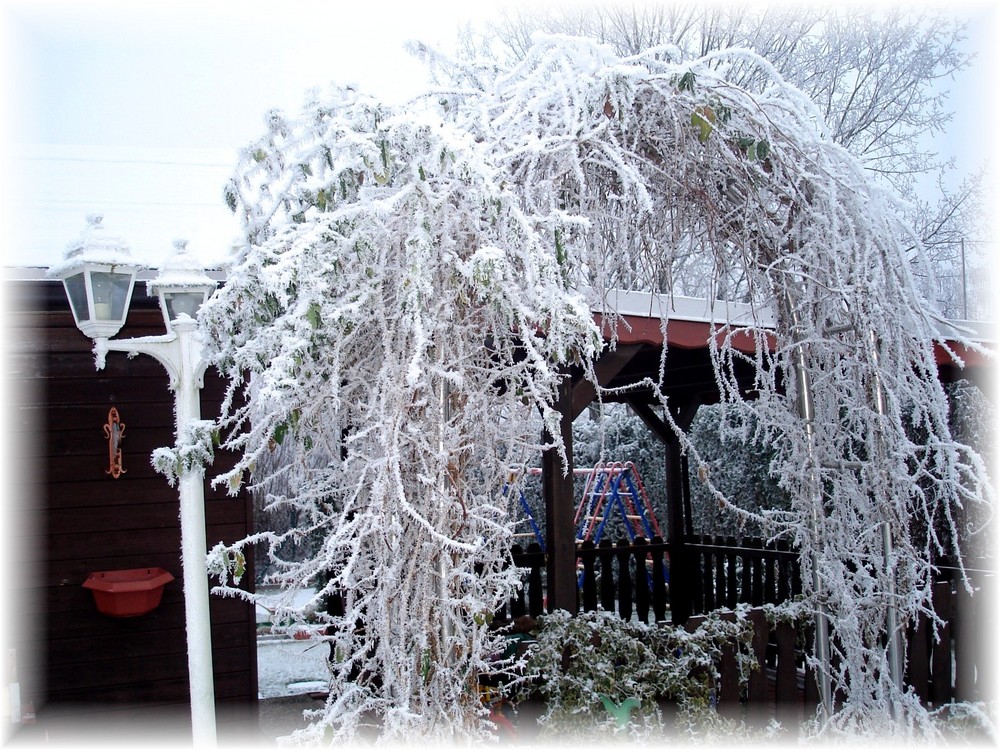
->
[8,282,257,732]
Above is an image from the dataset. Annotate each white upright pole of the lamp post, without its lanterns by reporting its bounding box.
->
[173,318,216,747]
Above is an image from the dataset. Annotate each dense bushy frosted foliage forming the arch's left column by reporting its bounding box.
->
[203,83,599,740]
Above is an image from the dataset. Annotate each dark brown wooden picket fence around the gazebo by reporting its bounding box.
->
[498,537,995,721]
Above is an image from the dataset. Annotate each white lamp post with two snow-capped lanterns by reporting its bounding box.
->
[49,216,216,747]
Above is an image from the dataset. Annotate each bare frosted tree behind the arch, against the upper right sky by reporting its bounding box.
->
[487,2,989,318]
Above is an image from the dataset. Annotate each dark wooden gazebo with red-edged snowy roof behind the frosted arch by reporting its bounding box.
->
[542,291,995,624]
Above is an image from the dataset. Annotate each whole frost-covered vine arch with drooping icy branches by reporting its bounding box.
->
[203,37,988,740]
